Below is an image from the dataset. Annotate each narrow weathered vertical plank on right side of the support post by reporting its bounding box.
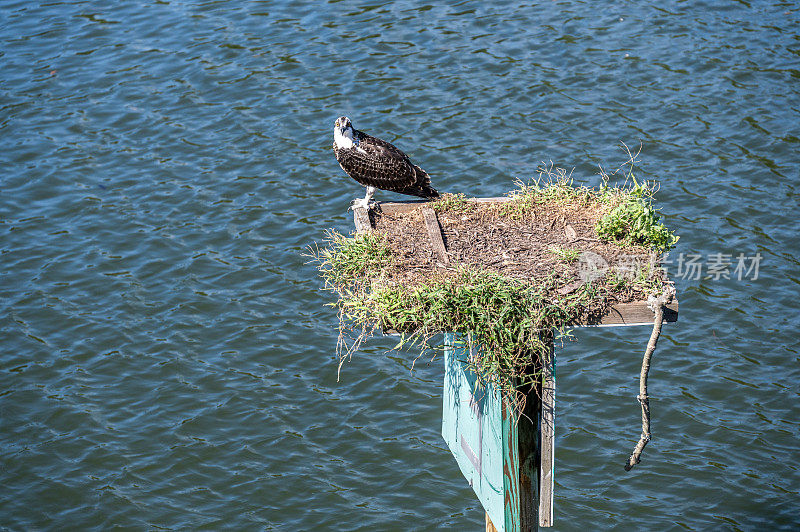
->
[539,340,556,527]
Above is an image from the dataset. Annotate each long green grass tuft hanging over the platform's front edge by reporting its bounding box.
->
[330,268,579,398]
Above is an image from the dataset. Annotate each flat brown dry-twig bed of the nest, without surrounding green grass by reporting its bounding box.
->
[370,192,666,323]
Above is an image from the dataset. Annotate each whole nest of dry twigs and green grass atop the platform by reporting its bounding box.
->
[316,180,677,406]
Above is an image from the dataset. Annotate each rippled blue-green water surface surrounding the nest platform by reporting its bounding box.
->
[0,0,800,530]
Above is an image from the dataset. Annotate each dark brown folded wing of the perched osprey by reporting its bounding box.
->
[333,131,439,198]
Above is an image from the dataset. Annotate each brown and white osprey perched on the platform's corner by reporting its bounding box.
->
[333,116,439,209]
